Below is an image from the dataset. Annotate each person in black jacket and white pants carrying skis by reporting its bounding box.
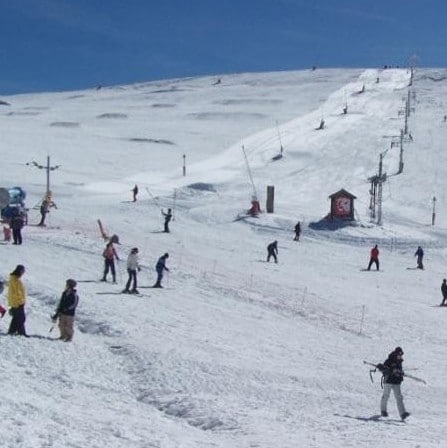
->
[377,347,410,420]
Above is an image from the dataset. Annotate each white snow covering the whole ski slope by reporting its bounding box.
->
[0,69,447,448]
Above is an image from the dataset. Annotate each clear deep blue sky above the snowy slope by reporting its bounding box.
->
[0,0,447,95]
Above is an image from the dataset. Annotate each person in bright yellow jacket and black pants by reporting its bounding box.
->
[8,264,28,337]
